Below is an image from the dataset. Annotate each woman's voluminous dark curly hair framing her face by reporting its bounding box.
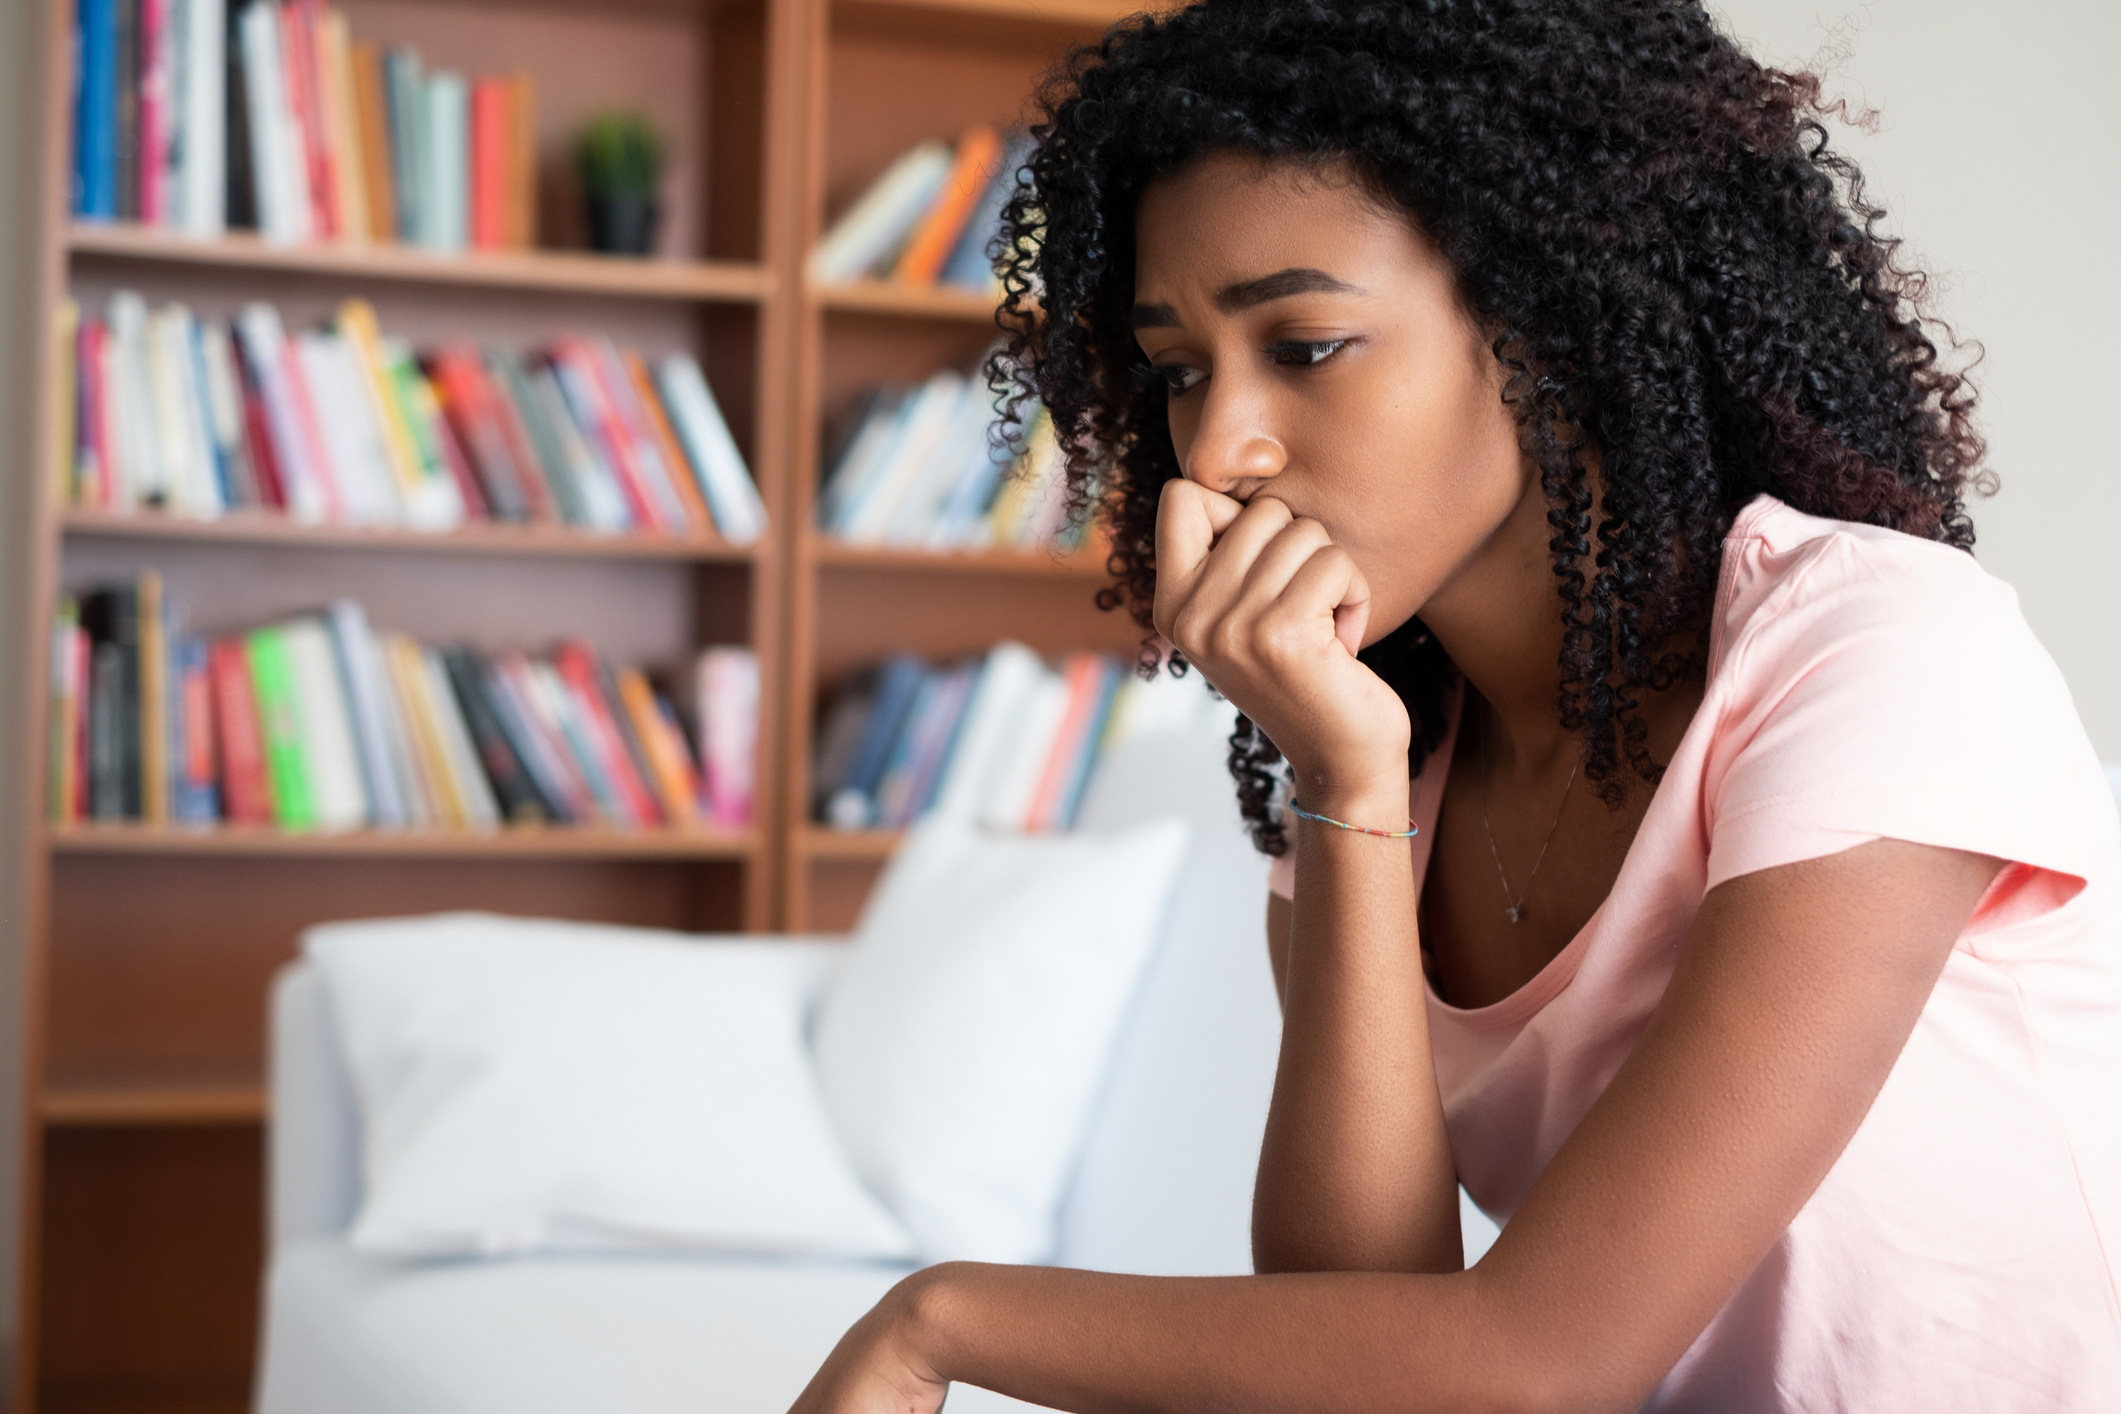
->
[988,0,1992,854]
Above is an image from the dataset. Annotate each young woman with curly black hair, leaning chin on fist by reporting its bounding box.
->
[797,0,2121,1414]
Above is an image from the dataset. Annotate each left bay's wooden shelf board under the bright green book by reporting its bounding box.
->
[49,820,759,861]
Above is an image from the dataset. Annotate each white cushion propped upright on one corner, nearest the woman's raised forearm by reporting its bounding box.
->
[814,818,1190,1261]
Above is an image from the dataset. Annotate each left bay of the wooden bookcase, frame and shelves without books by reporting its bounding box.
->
[8,0,825,1414]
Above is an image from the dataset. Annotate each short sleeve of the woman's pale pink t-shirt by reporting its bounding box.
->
[1703,528,2121,924]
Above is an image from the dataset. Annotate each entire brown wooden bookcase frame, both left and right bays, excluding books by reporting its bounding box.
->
[11,0,1137,1414]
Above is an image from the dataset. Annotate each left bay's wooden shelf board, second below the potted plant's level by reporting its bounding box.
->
[59,509,759,564]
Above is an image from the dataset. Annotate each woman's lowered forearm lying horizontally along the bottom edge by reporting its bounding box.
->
[912,1263,1553,1414]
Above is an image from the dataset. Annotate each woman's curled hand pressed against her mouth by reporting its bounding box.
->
[1154,477,1413,825]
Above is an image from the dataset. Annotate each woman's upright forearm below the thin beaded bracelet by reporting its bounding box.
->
[1251,801,1463,1272]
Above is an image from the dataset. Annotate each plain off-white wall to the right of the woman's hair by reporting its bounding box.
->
[1712,0,2121,761]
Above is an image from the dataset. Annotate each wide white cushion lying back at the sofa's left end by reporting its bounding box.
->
[305,914,912,1257]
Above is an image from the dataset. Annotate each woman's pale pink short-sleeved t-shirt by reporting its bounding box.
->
[1273,496,2121,1414]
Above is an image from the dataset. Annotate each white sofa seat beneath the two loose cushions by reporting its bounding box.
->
[255,1240,1060,1414]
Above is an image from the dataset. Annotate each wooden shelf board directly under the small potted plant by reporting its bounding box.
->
[66,223,774,303]
